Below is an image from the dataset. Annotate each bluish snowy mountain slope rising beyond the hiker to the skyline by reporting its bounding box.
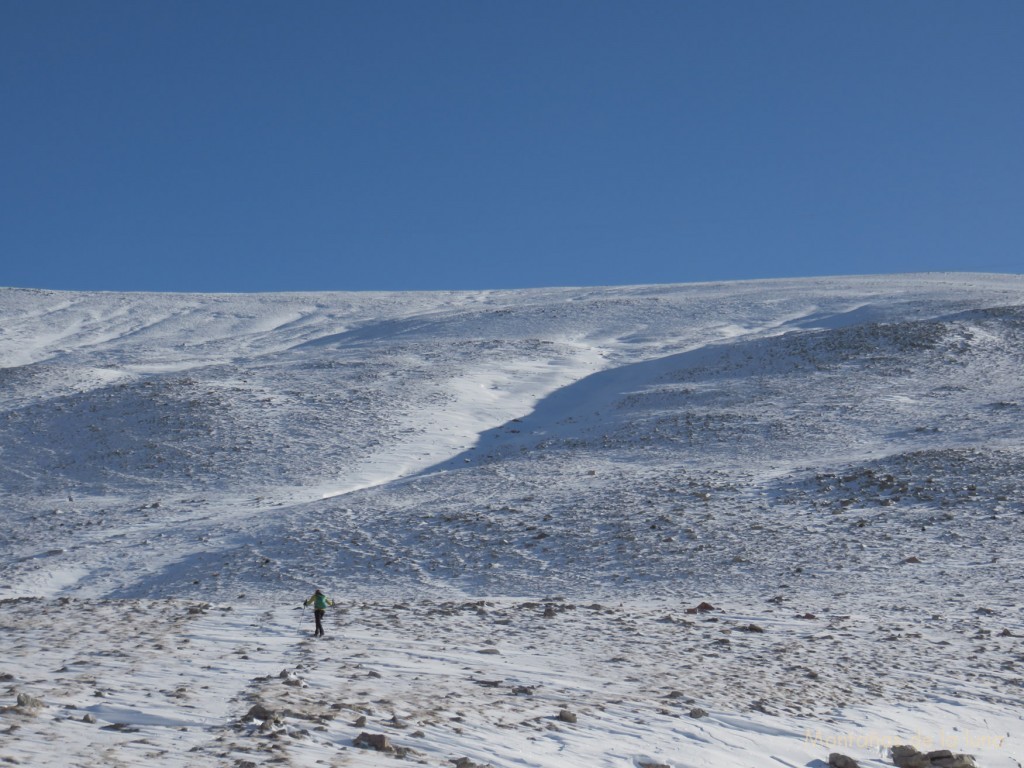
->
[0,274,1024,596]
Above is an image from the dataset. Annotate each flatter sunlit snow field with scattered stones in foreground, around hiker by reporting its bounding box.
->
[0,599,1022,766]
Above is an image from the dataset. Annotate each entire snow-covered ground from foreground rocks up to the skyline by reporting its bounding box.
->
[0,273,1024,768]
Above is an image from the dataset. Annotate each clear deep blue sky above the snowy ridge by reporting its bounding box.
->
[0,0,1024,291]
